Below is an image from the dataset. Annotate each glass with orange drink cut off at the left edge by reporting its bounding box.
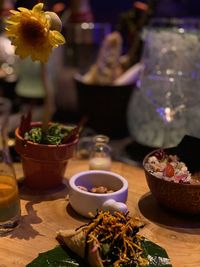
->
[0,97,21,235]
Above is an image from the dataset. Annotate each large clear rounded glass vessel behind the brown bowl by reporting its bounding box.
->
[127,19,200,147]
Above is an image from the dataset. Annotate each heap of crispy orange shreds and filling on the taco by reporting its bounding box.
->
[78,211,148,267]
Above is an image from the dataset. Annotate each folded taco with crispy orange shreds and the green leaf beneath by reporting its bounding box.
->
[27,211,172,267]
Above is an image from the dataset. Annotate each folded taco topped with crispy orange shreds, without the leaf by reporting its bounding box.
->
[57,211,148,267]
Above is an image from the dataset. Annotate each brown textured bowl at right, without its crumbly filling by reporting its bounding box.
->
[143,148,200,215]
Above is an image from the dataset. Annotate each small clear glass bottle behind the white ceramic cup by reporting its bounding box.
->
[89,135,112,170]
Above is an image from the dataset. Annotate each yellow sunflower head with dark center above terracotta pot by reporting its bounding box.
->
[6,3,65,63]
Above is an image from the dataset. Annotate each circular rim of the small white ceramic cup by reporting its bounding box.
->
[69,170,128,198]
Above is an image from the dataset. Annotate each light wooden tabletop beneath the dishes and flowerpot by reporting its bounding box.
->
[0,160,200,267]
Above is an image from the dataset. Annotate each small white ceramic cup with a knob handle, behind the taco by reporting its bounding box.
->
[69,170,128,217]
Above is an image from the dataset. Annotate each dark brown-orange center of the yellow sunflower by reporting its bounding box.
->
[20,18,46,45]
